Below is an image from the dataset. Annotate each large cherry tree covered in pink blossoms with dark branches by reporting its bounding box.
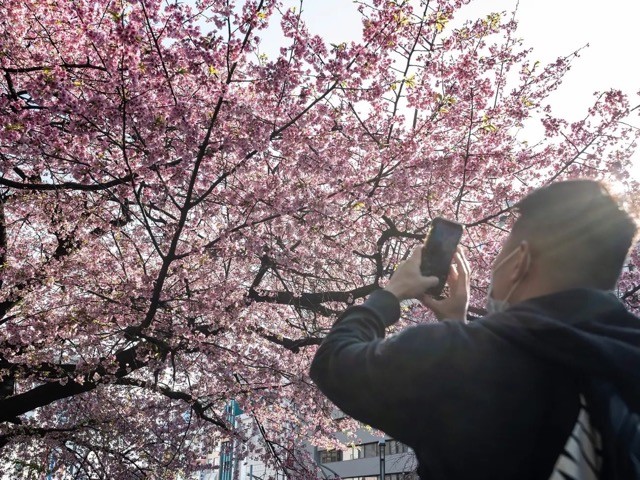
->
[0,0,640,478]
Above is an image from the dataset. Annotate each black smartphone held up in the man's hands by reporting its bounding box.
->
[420,217,462,297]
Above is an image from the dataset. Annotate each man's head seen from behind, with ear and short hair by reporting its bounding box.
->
[493,180,637,302]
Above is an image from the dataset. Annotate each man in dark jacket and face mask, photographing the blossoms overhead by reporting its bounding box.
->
[311,180,640,480]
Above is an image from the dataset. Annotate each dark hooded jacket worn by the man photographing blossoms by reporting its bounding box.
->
[311,289,640,480]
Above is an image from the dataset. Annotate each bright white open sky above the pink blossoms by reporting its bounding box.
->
[263,0,640,178]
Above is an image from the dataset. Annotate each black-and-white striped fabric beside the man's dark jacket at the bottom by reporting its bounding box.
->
[549,395,602,480]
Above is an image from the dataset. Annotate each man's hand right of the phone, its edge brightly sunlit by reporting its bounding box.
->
[418,247,470,321]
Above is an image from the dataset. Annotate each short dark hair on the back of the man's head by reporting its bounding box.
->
[512,180,638,290]
